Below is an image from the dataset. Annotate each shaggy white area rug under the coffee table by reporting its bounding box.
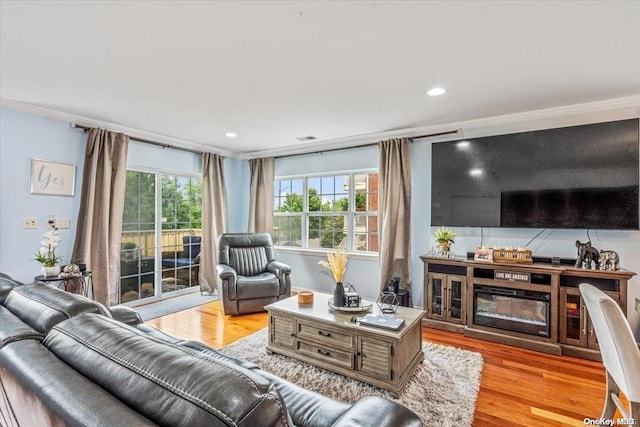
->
[220,328,484,427]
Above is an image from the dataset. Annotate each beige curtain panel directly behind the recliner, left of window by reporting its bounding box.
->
[247,157,275,233]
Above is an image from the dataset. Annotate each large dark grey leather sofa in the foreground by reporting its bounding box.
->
[0,276,422,427]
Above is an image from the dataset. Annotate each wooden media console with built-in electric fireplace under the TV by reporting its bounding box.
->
[420,255,635,360]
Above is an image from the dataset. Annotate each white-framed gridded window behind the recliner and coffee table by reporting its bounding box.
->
[272,172,378,252]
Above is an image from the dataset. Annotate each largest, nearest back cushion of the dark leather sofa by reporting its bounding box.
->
[44,313,291,426]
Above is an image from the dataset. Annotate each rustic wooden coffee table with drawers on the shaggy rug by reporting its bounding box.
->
[265,292,424,397]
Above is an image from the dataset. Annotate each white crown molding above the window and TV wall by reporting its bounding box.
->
[238,95,640,160]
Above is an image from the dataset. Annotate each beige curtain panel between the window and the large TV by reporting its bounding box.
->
[378,138,411,301]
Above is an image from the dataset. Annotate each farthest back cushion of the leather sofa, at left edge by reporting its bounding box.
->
[3,283,111,334]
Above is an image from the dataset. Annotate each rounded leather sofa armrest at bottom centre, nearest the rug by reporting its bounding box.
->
[333,396,422,427]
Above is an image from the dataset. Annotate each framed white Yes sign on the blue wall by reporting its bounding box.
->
[31,159,76,196]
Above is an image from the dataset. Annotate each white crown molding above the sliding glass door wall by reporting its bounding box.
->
[0,98,237,157]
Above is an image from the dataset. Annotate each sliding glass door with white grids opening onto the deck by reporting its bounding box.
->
[119,171,202,303]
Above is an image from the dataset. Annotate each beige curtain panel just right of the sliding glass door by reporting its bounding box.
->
[199,153,227,294]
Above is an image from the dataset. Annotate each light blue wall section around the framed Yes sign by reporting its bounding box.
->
[0,109,86,282]
